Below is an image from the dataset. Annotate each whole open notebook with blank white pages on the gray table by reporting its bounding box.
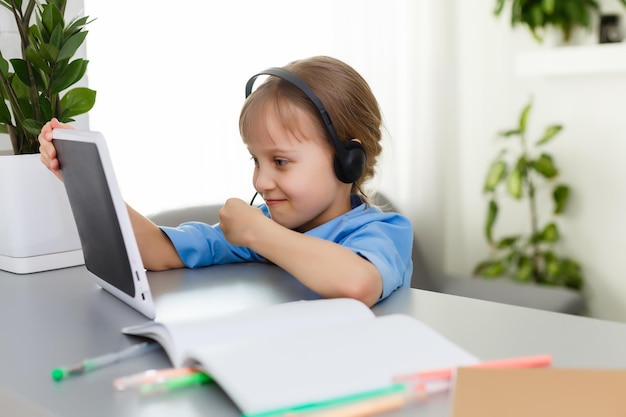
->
[122,298,478,417]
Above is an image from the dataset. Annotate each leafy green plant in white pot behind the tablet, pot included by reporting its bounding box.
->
[0,0,96,273]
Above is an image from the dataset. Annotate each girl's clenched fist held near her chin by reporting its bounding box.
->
[219,198,271,247]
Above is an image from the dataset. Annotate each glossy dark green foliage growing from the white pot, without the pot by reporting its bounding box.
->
[0,0,96,155]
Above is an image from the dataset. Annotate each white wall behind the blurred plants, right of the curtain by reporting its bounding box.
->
[445,0,626,321]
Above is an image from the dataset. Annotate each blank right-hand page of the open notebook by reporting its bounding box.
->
[189,314,478,414]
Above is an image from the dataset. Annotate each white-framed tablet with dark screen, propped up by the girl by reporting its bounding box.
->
[52,129,155,319]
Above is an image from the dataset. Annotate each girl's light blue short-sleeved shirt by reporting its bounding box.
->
[161,194,413,301]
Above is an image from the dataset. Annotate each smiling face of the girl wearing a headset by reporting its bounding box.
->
[247,102,351,232]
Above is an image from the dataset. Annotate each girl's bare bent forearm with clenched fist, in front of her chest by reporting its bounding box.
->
[220,199,383,306]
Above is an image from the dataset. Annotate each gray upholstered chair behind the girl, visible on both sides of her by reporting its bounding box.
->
[148,193,585,314]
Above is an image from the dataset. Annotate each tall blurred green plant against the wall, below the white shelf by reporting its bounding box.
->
[474,102,584,290]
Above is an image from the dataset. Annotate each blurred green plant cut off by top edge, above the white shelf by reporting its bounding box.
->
[494,0,626,43]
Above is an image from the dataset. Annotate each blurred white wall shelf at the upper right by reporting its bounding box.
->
[515,42,626,77]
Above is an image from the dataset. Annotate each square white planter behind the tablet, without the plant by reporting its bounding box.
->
[0,154,84,274]
